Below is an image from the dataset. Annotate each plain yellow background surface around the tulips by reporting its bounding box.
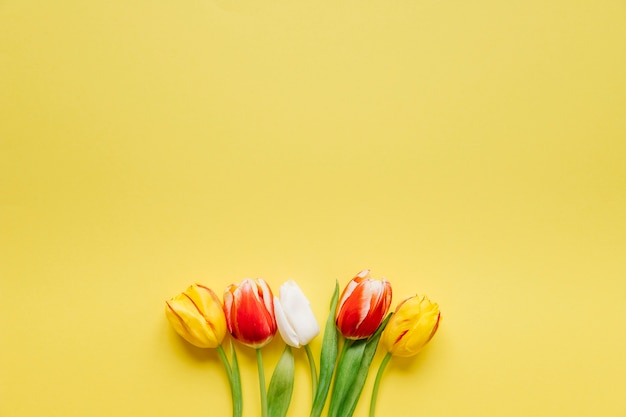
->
[0,0,626,417]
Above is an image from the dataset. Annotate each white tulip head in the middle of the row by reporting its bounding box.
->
[274,280,320,348]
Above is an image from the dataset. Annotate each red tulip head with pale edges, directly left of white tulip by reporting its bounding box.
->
[224,278,276,348]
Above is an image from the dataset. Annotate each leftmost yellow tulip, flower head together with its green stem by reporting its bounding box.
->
[165,284,243,417]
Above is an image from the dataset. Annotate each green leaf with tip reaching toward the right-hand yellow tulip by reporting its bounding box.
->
[328,313,391,417]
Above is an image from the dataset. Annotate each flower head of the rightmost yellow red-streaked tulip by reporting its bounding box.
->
[381,295,441,357]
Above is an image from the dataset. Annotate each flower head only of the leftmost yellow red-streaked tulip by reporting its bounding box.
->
[165,284,226,348]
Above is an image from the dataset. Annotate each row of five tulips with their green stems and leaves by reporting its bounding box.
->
[165,270,441,417]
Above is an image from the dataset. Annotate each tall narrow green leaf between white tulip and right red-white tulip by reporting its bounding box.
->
[310,282,339,417]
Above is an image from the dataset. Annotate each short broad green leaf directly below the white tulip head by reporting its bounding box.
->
[267,345,294,417]
